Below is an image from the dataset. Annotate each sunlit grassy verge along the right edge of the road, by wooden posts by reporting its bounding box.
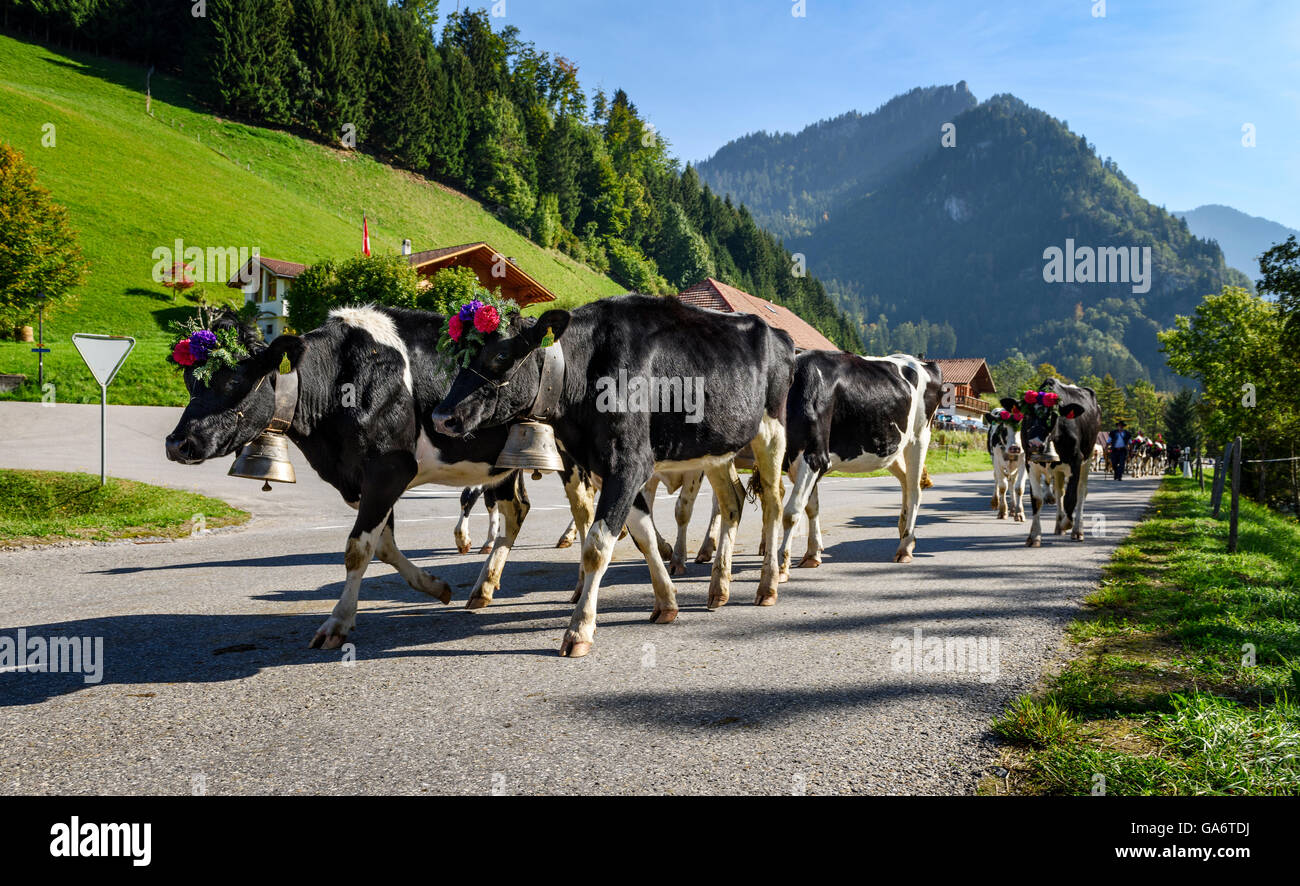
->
[980,478,1300,795]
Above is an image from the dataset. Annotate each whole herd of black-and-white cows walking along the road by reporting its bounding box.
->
[166,295,1128,657]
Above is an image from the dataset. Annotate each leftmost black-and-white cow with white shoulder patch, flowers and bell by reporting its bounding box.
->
[166,307,529,650]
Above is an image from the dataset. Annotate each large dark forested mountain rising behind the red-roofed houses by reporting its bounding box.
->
[701,83,1247,387]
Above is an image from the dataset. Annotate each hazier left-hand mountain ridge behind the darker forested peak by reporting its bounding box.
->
[698,81,976,238]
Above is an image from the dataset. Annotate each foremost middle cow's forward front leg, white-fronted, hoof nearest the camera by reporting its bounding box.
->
[560,456,655,659]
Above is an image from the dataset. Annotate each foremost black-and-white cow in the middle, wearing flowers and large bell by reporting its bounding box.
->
[434,295,794,657]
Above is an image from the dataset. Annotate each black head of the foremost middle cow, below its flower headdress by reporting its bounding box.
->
[433,310,569,437]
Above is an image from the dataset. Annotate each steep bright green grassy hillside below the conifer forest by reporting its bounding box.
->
[0,35,623,404]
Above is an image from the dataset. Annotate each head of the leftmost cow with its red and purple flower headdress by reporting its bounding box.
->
[166,314,304,465]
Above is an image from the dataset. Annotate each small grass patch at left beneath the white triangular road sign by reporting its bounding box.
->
[0,470,248,546]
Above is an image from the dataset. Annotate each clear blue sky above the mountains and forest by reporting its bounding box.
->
[488,0,1300,227]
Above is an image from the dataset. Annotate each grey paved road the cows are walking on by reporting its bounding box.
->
[0,404,1154,794]
